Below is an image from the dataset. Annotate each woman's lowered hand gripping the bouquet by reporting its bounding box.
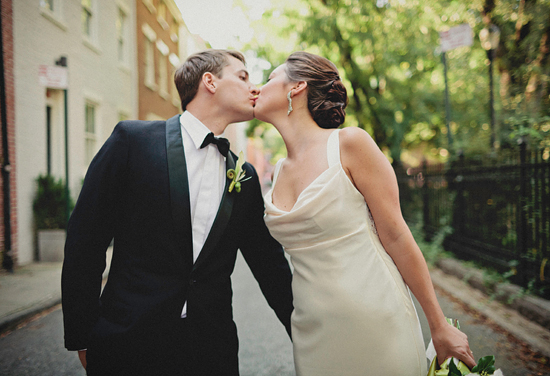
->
[432,324,476,369]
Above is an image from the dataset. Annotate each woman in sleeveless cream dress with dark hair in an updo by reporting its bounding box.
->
[255,52,475,376]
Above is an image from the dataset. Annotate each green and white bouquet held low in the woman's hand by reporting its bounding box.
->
[426,319,503,376]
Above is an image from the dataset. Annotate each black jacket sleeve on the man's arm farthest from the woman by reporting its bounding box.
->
[61,122,129,350]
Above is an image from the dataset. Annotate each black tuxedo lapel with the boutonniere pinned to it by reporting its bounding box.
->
[193,152,236,270]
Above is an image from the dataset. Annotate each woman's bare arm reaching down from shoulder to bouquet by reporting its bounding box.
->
[340,127,475,368]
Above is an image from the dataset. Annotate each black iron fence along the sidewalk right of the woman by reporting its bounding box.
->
[397,143,550,298]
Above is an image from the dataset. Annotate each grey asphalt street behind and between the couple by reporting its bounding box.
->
[0,257,550,376]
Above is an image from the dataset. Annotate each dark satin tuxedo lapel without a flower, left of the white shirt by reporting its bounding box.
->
[166,115,193,263]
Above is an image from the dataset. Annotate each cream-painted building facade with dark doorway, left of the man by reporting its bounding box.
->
[12,0,138,265]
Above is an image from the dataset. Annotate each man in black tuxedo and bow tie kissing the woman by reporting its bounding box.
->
[62,50,293,376]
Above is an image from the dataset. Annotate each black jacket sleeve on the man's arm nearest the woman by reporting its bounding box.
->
[239,163,294,336]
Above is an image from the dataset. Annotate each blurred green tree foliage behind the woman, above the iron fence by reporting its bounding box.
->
[241,0,550,166]
